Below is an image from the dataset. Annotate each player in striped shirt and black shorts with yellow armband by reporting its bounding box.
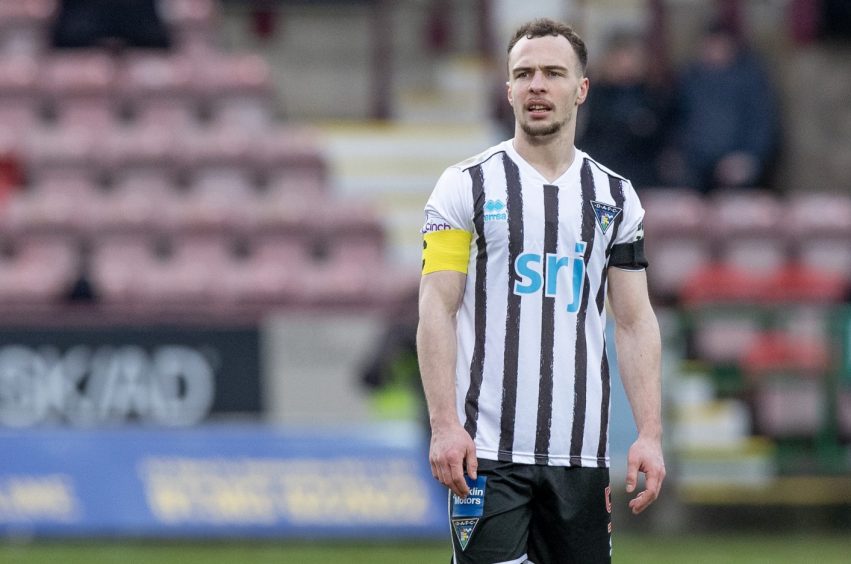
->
[417,20,665,564]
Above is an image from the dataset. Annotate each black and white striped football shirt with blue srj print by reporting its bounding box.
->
[425,140,644,467]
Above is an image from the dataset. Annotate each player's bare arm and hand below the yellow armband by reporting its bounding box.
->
[417,270,477,497]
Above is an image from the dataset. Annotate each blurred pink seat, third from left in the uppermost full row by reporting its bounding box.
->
[118,53,198,132]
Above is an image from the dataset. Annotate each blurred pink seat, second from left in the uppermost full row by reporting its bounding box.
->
[39,50,117,129]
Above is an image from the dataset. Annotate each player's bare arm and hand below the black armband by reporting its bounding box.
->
[608,268,665,514]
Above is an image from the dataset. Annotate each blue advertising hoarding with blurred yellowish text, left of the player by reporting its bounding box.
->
[0,426,448,539]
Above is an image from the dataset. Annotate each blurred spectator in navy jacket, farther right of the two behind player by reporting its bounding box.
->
[669,23,779,192]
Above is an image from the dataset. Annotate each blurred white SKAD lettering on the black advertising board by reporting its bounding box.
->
[0,345,215,427]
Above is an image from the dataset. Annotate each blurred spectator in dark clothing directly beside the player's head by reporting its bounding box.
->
[576,31,671,188]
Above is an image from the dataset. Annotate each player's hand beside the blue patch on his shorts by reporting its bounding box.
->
[429,423,479,497]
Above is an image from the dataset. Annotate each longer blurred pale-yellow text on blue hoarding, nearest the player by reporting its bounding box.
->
[139,458,429,527]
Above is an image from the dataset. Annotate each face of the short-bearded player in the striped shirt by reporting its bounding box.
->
[508,35,588,138]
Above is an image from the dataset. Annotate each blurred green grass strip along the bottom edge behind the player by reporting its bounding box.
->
[0,534,851,564]
